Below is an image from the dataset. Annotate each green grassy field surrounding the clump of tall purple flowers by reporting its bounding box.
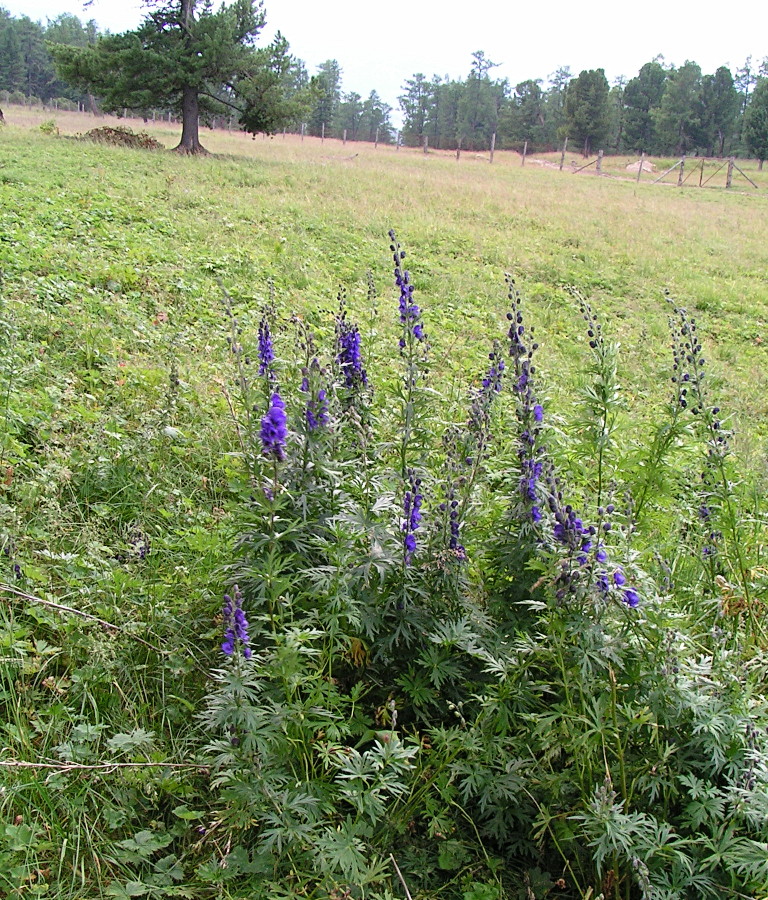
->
[0,107,768,900]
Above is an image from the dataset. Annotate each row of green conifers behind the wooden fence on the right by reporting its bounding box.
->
[400,51,768,159]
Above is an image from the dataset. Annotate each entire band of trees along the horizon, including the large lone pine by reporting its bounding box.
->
[0,0,768,164]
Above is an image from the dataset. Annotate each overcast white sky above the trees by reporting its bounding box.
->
[6,0,768,116]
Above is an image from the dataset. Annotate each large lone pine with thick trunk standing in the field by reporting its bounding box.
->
[50,0,292,153]
